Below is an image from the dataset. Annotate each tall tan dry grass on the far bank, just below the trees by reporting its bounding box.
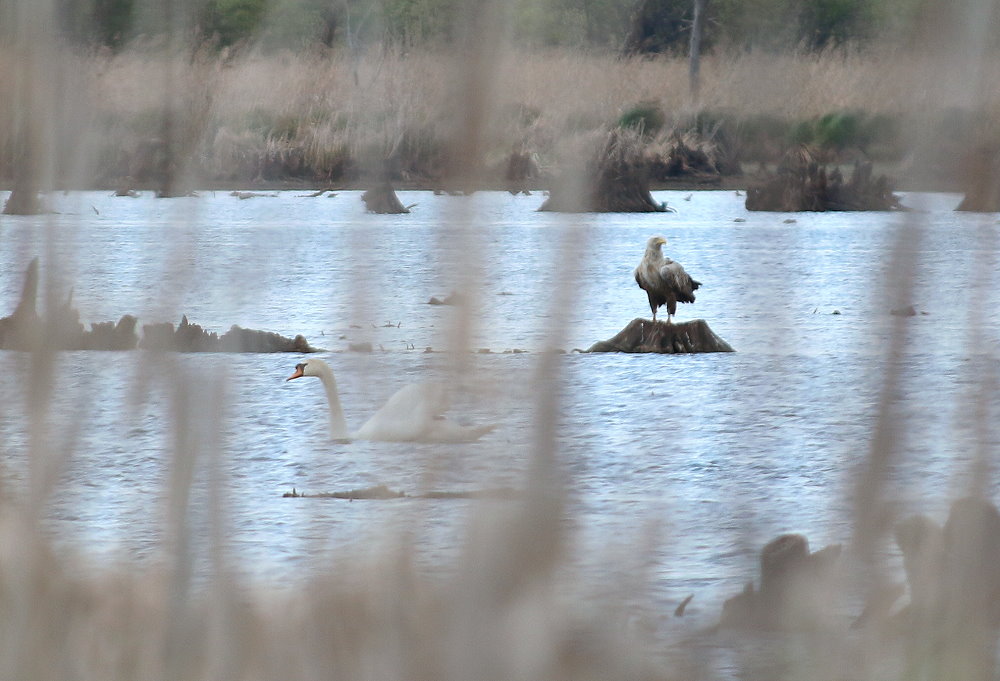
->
[0,48,1000,186]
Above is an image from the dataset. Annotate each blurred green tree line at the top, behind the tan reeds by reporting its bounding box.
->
[15,0,1000,53]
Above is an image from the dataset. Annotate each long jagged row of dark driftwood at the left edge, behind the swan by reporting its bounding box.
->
[0,258,316,352]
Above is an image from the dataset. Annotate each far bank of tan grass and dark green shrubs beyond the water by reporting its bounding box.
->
[0,50,1000,188]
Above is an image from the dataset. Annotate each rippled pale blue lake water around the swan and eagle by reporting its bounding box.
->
[0,191,1000,636]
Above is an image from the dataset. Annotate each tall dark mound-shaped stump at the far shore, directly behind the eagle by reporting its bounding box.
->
[538,131,667,213]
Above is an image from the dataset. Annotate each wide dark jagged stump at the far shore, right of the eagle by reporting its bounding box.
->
[746,147,903,213]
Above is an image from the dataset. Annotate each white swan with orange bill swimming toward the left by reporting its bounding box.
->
[286,359,496,442]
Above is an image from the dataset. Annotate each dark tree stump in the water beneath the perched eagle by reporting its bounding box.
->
[587,318,733,354]
